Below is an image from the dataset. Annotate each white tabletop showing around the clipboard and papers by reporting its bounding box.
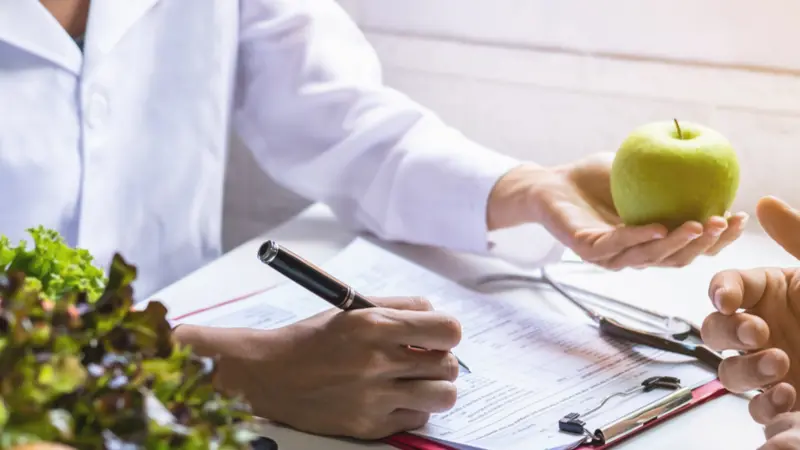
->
[153,205,797,450]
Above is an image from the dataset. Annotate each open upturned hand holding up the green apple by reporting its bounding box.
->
[540,153,747,270]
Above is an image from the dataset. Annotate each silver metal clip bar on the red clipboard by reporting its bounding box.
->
[591,387,693,446]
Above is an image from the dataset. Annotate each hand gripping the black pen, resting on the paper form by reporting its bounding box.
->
[178,298,461,439]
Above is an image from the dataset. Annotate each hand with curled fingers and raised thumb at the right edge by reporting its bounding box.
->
[703,197,800,424]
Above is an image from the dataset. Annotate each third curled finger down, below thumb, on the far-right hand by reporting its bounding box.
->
[719,348,789,393]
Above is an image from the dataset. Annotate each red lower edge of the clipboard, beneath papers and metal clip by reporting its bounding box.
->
[384,379,728,450]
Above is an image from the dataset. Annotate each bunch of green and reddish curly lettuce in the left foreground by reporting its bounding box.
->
[0,228,256,450]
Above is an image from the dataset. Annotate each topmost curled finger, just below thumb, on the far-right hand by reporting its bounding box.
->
[708,269,784,315]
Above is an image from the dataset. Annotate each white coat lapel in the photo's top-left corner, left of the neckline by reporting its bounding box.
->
[0,0,83,75]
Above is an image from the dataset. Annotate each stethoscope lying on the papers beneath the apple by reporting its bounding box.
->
[475,261,723,373]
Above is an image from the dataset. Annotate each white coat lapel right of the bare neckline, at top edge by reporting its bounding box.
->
[85,0,160,59]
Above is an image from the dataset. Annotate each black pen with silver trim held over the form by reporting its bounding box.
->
[258,241,470,372]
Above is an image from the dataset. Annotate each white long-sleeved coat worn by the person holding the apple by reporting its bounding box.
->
[0,0,556,299]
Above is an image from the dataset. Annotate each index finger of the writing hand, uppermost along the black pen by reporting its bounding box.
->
[364,308,461,351]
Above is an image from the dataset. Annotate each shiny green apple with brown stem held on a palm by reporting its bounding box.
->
[611,120,739,230]
